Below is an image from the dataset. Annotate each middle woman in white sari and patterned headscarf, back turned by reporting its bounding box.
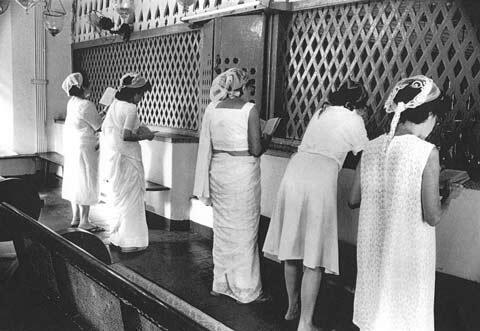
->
[194,68,270,303]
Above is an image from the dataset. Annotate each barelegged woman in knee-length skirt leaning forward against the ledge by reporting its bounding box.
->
[263,81,368,330]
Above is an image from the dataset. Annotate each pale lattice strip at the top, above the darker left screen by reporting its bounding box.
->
[72,0,254,43]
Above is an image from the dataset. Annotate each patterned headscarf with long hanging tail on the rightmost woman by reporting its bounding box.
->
[385,75,440,144]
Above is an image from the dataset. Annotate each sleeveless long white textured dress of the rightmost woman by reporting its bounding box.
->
[353,135,435,331]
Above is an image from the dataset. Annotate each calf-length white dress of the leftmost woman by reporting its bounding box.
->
[62,96,102,206]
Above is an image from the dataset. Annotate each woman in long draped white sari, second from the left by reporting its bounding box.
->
[101,73,154,253]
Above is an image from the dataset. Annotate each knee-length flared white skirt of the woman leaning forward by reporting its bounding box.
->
[263,152,338,274]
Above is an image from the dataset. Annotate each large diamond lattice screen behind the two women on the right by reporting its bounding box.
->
[284,0,480,139]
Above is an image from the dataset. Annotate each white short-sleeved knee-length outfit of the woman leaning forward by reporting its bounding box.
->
[263,106,368,274]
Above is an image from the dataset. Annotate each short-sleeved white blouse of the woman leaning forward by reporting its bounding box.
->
[298,106,368,167]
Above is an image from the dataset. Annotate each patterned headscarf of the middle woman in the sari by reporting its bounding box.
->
[210,68,248,101]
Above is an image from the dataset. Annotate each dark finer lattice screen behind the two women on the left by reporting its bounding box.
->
[74,31,200,130]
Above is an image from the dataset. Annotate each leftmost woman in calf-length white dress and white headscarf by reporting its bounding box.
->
[62,72,104,232]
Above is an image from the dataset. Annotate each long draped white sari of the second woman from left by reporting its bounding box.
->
[101,99,148,248]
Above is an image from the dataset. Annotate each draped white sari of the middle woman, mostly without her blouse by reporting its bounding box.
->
[194,104,262,303]
